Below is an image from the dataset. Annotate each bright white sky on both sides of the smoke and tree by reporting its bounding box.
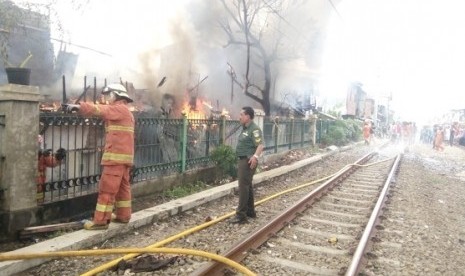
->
[12,0,465,121]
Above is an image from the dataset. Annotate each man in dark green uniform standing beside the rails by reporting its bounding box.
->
[231,106,264,224]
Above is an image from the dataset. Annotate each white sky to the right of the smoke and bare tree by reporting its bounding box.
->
[321,0,465,121]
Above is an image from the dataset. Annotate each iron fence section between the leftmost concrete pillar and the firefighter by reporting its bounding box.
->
[39,113,105,202]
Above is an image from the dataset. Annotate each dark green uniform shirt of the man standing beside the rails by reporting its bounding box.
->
[236,121,263,158]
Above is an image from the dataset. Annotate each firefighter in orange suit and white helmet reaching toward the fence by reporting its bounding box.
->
[65,83,134,230]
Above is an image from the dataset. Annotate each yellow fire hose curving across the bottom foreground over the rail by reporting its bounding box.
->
[0,247,256,276]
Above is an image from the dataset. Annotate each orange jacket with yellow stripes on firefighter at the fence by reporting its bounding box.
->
[79,100,135,166]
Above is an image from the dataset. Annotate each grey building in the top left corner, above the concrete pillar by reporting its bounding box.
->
[0,1,78,86]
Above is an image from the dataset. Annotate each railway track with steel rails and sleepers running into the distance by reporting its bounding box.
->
[192,150,400,275]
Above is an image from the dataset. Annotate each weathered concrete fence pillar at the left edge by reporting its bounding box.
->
[0,84,41,237]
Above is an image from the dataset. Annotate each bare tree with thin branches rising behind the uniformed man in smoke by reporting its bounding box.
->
[219,0,318,116]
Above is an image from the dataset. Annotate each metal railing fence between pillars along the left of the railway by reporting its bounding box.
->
[40,113,330,203]
